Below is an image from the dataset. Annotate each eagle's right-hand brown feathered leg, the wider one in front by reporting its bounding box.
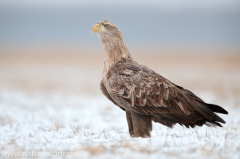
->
[131,111,152,137]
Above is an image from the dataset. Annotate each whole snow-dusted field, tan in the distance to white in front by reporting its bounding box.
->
[0,54,240,159]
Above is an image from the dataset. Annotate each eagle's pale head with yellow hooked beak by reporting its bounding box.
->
[91,20,122,39]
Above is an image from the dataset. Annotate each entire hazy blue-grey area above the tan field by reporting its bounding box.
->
[0,0,240,46]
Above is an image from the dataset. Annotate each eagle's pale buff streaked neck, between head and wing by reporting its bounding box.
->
[99,35,132,77]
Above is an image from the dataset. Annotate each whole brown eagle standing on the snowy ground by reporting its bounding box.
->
[92,20,228,137]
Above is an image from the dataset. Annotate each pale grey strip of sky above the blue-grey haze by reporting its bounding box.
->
[0,0,240,11]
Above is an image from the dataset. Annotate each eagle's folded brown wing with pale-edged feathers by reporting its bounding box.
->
[108,62,226,126]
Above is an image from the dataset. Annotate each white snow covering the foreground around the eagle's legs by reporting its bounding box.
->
[0,90,240,159]
